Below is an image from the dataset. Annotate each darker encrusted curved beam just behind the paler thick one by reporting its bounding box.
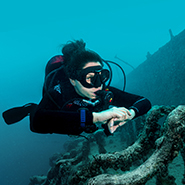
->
[70,106,174,184]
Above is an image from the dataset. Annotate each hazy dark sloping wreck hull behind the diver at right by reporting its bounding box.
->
[126,30,185,105]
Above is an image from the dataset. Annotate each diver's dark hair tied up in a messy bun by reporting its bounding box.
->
[62,40,103,79]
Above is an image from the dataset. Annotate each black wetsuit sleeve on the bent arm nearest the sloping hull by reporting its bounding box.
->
[109,87,151,118]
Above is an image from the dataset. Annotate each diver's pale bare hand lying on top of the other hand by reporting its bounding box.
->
[93,107,132,123]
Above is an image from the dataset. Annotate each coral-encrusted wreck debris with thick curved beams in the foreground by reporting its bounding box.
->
[30,106,185,185]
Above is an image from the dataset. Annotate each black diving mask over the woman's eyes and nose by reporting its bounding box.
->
[76,66,109,88]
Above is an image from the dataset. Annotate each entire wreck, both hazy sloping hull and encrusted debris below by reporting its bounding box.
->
[30,30,185,185]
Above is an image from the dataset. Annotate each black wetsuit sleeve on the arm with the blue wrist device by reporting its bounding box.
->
[30,99,93,135]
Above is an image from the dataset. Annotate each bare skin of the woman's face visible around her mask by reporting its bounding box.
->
[70,62,103,99]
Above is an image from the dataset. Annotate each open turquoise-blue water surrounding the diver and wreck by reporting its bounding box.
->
[0,0,185,185]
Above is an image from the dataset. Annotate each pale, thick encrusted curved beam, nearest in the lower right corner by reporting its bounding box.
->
[88,106,185,185]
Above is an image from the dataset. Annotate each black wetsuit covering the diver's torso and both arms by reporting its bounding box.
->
[30,56,151,135]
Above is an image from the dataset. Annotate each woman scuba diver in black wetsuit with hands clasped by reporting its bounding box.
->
[3,40,151,136]
